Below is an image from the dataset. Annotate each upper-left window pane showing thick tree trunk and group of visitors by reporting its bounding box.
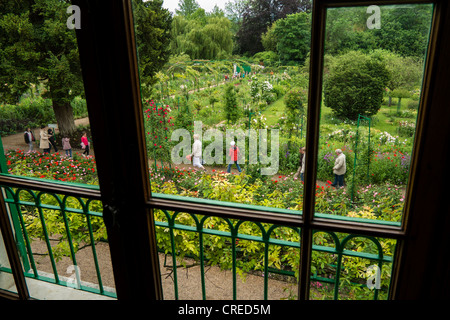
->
[0,0,97,184]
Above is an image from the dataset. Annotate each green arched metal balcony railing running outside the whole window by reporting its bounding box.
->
[0,182,395,299]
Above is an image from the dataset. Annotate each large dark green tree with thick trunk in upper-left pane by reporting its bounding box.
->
[0,0,83,134]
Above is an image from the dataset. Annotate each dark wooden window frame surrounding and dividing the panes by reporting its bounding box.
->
[0,0,450,300]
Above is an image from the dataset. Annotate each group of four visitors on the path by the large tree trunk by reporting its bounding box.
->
[24,126,90,158]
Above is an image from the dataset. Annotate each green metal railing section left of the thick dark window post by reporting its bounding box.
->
[0,187,116,297]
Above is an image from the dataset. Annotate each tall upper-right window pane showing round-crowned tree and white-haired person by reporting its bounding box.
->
[315,4,433,225]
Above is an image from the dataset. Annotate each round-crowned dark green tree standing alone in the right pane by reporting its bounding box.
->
[324,51,389,120]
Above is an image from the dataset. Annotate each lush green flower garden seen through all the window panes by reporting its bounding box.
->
[0,1,430,299]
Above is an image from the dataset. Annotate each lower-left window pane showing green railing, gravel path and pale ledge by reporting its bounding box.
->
[3,187,116,300]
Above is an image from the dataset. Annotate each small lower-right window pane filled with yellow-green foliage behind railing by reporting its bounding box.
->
[310,231,396,300]
